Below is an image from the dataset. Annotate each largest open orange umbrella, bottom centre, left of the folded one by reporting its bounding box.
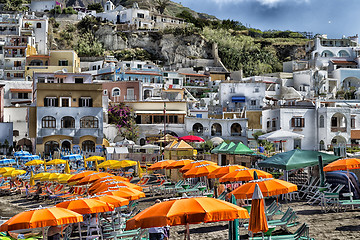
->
[126,197,249,230]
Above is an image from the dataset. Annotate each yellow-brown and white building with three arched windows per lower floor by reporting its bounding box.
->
[29,72,103,155]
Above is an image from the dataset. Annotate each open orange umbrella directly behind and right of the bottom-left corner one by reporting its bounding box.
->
[55,198,114,214]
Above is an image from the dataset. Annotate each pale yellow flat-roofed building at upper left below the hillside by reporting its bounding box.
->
[25,50,81,80]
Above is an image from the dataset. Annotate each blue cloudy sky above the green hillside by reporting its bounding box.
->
[175,0,360,38]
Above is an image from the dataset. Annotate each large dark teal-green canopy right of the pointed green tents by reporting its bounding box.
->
[258,149,340,170]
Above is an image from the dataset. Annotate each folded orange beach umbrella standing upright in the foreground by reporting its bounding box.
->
[248,184,269,234]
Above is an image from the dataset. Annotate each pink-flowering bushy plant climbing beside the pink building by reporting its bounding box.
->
[108,103,139,141]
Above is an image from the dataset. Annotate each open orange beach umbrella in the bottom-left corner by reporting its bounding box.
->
[0,207,83,232]
